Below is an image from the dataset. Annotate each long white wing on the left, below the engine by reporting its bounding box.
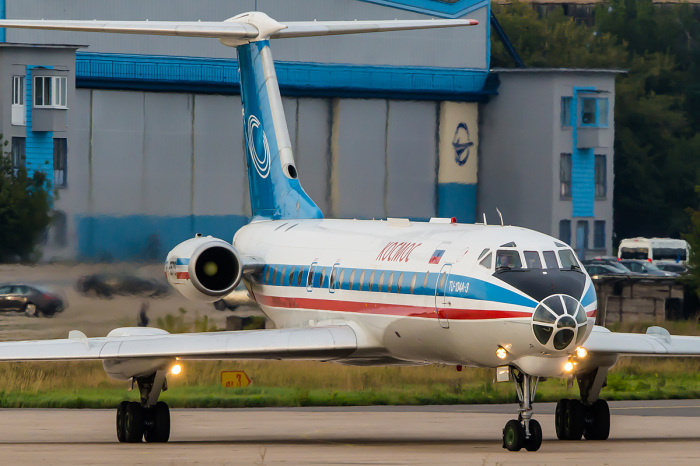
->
[0,325,357,361]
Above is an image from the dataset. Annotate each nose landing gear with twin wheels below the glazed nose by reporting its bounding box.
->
[503,369,542,451]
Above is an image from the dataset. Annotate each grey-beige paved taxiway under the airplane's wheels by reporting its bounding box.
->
[0,400,700,466]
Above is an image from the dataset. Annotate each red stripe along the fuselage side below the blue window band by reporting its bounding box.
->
[255,293,532,320]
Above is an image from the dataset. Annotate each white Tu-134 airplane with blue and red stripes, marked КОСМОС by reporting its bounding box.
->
[0,12,700,451]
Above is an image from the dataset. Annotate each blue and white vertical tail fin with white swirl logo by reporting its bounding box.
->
[236,40,323,220]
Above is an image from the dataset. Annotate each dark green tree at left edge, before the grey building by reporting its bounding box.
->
[0,135,51,262]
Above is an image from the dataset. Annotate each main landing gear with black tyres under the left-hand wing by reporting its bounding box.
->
[117,370,170,443]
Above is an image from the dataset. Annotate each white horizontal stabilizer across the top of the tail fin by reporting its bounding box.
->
[0,18,479,40]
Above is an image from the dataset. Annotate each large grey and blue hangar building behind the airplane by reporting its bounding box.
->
[0,0,614,260]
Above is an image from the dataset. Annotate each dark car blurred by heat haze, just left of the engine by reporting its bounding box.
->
[76,273,170,298]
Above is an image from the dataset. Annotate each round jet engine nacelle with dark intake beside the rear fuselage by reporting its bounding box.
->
[165,235,243,303]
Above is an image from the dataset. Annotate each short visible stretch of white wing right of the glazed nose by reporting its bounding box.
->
[583,326,700,356]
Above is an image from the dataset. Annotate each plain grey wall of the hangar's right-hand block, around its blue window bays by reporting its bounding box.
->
[478,70,615,255]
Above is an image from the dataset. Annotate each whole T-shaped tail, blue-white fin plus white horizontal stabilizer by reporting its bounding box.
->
[0,11,479,219]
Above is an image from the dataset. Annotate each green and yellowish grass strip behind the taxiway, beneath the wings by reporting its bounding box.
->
[0,322,700,408]
